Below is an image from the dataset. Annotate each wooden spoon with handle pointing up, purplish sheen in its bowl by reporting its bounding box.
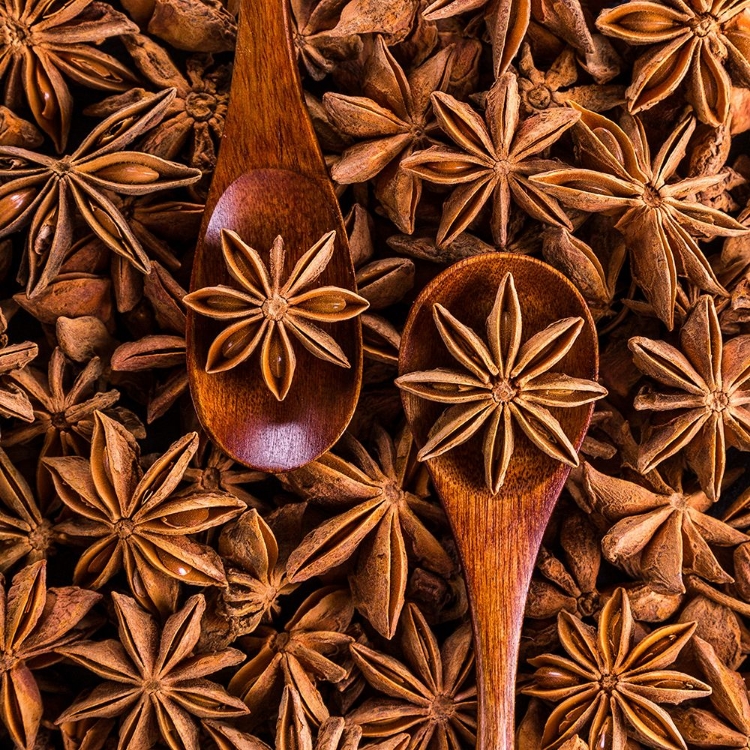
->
[187,0,362,472]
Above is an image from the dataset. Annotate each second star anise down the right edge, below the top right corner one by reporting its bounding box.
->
[530,103,747,329]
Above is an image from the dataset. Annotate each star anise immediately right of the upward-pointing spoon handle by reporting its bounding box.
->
[323,36,452,234]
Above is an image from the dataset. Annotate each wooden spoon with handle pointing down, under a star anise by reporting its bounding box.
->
[399,253,598,750]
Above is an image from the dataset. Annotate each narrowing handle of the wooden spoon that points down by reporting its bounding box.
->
[450,484,568,750]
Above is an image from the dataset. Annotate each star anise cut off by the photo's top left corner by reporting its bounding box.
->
[0,0,138,152]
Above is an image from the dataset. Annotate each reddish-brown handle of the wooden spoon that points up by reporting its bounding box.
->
[208,0,328,197]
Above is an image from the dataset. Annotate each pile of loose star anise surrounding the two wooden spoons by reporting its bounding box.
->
[0,0,750,750]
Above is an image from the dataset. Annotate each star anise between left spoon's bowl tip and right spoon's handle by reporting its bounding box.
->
[287,428,454,638]
